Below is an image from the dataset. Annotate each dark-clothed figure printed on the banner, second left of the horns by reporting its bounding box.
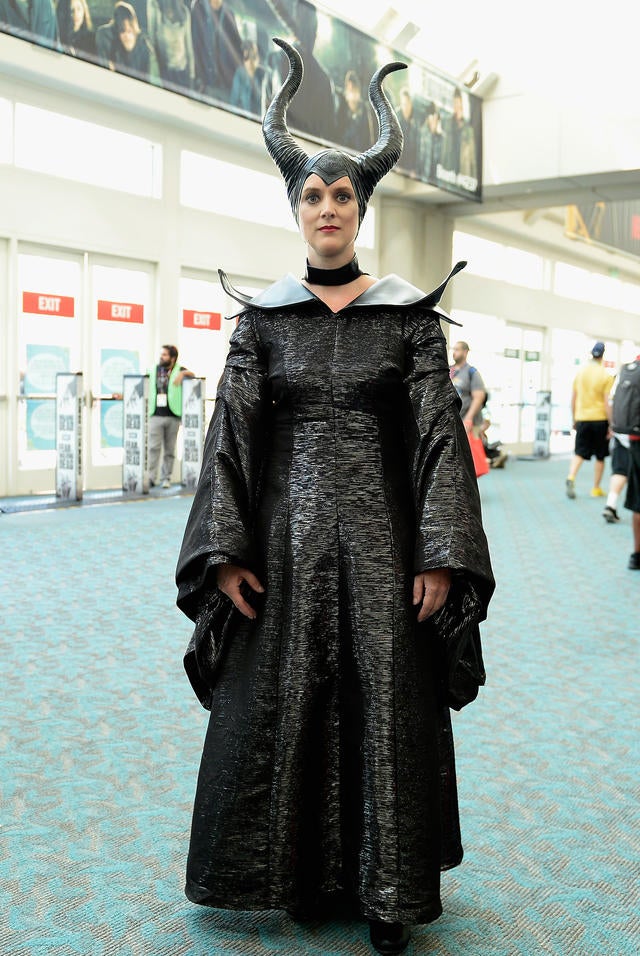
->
[191,0,242,103]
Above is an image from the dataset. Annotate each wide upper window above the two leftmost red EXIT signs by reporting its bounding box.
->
[15,103,161,198]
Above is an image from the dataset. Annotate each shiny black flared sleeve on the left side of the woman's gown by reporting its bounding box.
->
[176,313,269,621]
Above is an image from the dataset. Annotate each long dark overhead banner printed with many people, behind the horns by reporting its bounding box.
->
[0,0,482,201]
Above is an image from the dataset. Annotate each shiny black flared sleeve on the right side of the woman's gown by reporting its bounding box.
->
[405,310,495,709]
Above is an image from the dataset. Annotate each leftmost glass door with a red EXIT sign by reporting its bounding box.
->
[15,249,86,495]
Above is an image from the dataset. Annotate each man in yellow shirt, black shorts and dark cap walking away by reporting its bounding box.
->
[566,342,613,498]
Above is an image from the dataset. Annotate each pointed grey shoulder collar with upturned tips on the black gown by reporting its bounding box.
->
[218,262,467,325]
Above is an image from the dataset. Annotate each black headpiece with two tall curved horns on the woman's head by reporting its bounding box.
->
[262,37,407,223]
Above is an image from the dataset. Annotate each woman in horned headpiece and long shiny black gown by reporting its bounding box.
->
[177,40,493,953]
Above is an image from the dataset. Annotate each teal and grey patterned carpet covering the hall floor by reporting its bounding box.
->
[0,460,640,956]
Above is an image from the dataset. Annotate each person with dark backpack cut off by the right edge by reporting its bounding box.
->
[611,355,640,571]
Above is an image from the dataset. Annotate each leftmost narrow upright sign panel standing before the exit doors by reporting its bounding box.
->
[56,372,83,501]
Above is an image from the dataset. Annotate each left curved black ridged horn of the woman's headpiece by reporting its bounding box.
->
[262,37,309,204]
